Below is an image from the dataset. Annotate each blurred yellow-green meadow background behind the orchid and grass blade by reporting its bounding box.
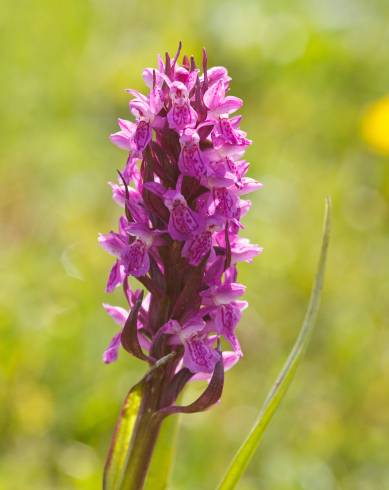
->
[0,0,389,490]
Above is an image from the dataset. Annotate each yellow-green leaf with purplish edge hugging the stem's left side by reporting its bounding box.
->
[103,381,143,490]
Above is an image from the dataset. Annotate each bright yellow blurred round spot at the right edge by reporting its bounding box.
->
[362,96,389,155]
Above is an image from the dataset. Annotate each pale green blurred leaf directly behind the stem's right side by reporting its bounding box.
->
[145,415,180,490]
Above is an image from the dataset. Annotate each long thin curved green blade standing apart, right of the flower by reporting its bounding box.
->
[218,198,331,490]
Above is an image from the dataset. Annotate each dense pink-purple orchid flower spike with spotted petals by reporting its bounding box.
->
[99,45,261,412]
